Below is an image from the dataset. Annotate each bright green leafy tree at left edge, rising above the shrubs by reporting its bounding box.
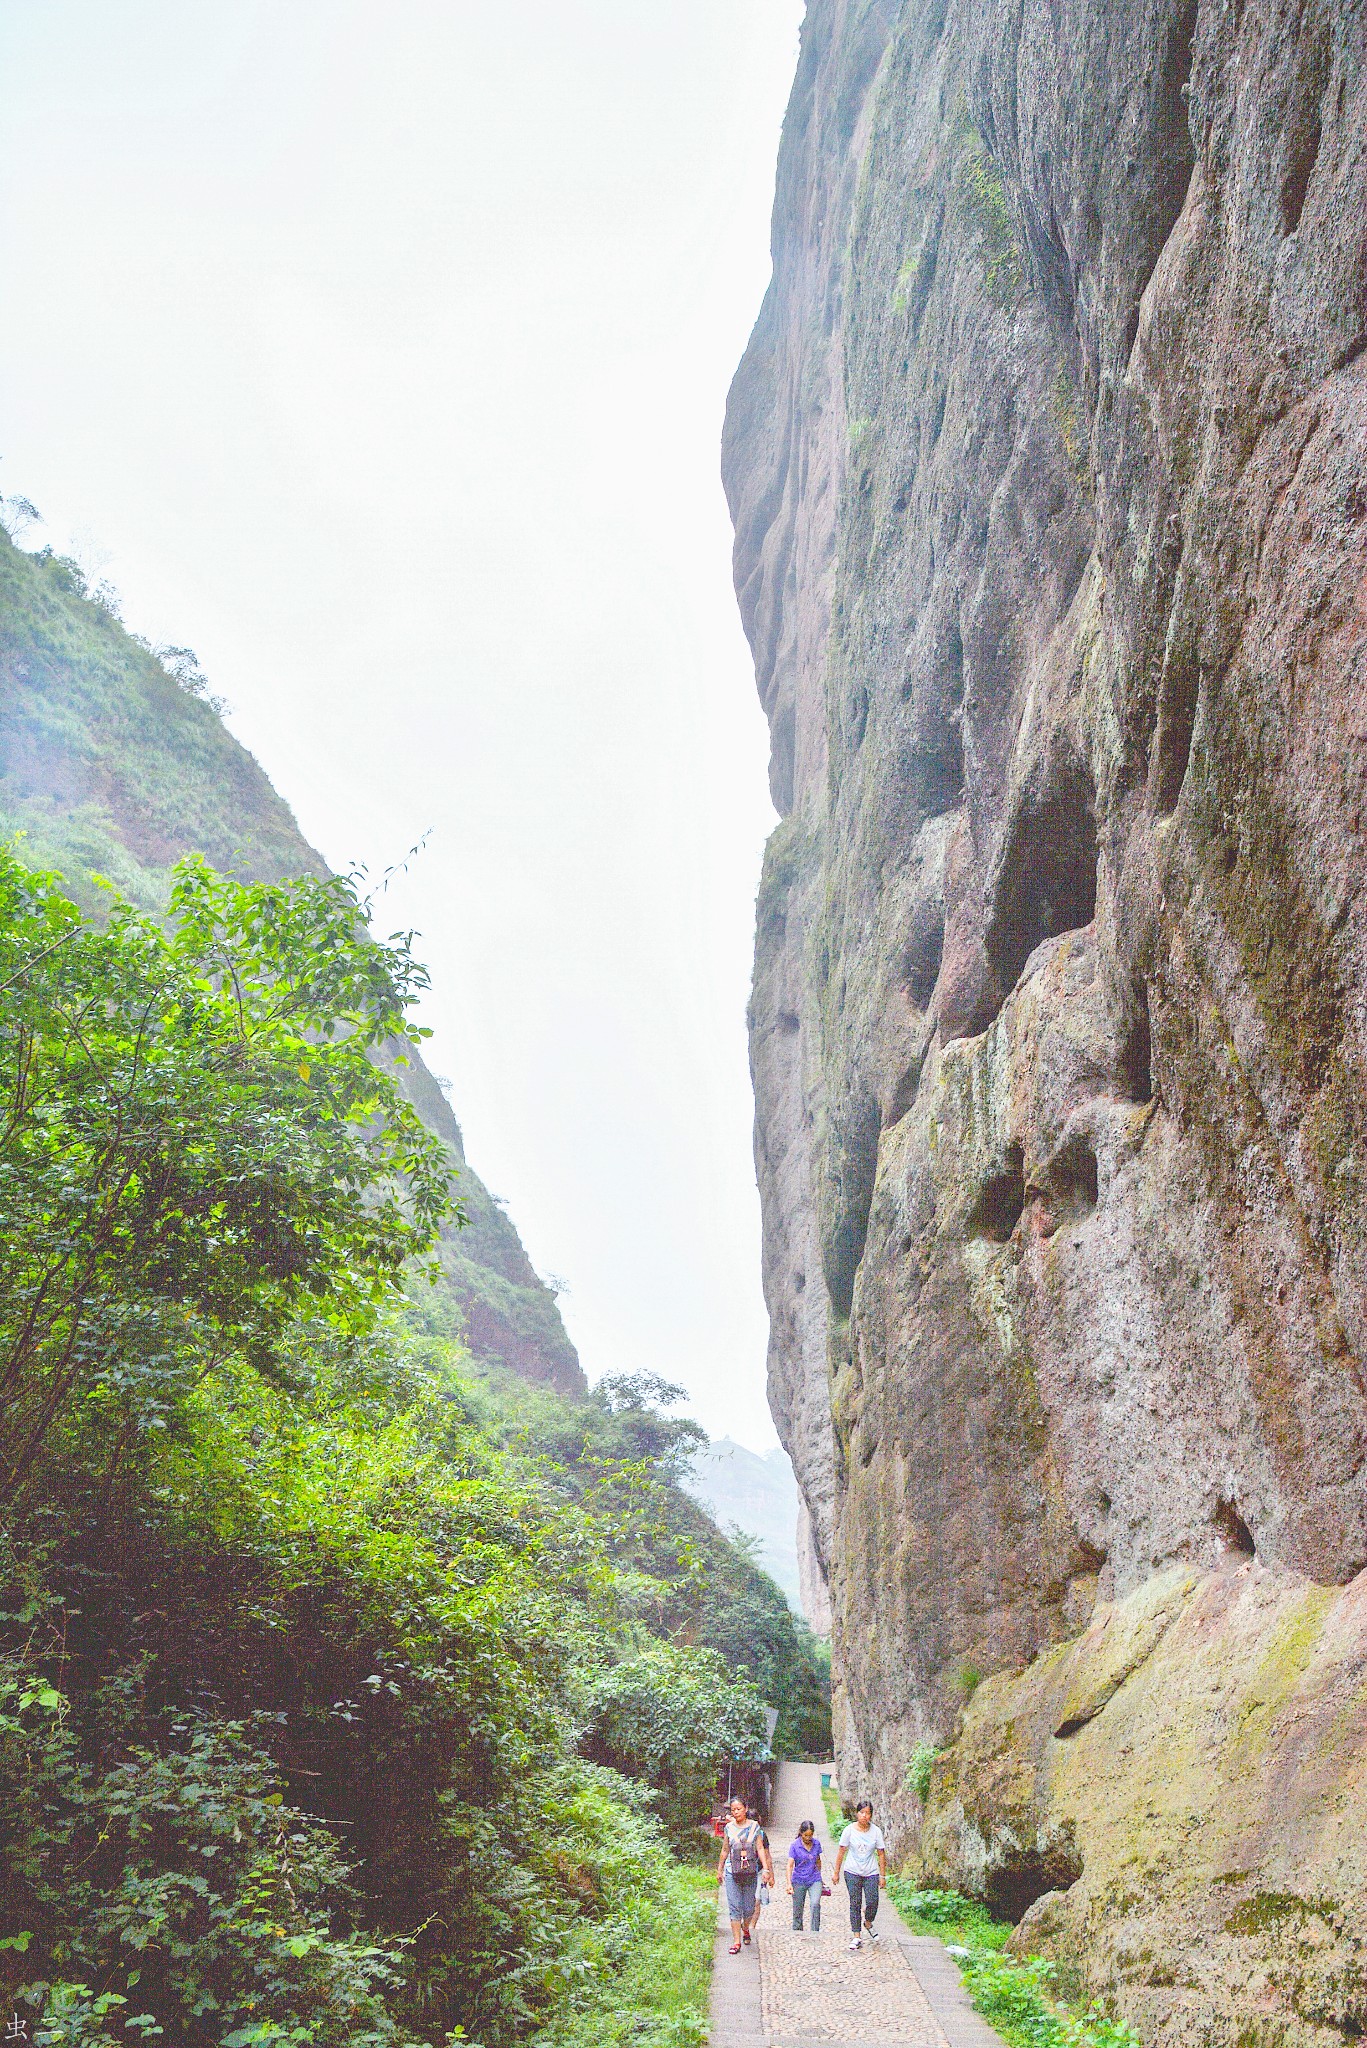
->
[0,850,455,1497]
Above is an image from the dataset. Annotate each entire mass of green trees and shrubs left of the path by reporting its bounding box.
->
[0,858,824,2048]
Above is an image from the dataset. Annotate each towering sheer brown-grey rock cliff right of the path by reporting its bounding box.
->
[723,0,1367,2042]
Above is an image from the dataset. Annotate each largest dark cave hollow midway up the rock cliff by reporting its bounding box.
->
[988,762,1096,995]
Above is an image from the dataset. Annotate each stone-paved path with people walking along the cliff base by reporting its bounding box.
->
[711,1763,1002,2048]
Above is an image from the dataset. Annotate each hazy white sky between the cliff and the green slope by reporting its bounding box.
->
[0,0,801,1448]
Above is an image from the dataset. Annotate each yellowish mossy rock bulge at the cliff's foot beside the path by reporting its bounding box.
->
[920,1561,1367,2048]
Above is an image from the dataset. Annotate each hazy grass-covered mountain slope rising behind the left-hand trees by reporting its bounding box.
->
[0,530,586,1393]
